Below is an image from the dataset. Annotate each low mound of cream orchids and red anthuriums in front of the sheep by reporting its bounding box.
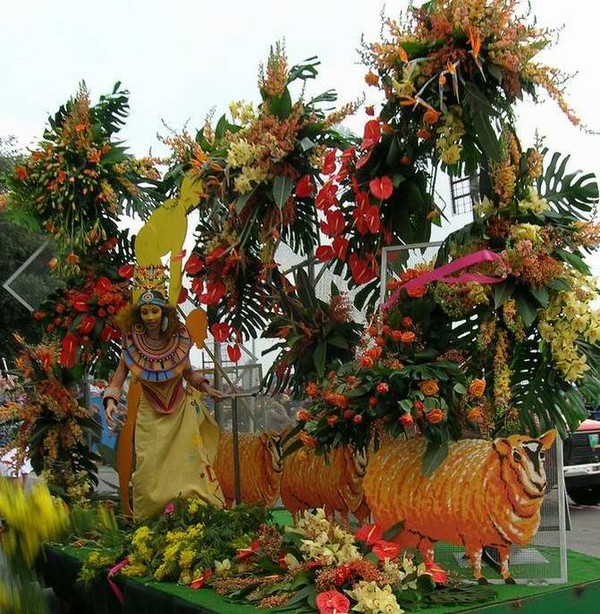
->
[210,509,495,614]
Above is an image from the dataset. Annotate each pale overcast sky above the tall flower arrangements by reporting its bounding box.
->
[0,0,600,258]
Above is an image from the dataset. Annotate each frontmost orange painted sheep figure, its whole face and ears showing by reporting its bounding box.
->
[363,431,556,584]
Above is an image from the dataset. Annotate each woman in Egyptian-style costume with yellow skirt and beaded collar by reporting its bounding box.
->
[104,289,224,520]
